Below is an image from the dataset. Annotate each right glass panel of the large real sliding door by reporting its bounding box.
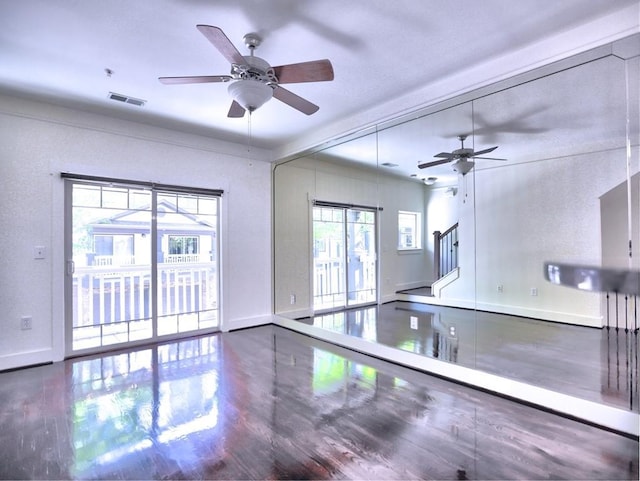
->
[156,193,218,336]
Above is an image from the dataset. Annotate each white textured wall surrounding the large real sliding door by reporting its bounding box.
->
[0,96,272,370]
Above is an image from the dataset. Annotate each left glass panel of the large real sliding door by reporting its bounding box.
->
[69,183,153,351]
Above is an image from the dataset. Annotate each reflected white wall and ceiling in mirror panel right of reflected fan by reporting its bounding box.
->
[470,52,627,327]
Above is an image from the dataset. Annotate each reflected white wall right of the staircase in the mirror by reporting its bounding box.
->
[442,150,626,327]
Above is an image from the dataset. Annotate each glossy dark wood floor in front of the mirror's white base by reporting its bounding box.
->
[0,326,638,479]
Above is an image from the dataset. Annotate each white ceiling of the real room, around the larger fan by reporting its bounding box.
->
[0,0,640,172]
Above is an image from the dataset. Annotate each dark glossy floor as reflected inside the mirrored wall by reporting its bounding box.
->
[299,301,638,412]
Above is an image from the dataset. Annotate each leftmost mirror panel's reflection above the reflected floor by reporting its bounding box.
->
[273,130,378,318]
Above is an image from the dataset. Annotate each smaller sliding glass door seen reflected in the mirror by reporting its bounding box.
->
[313,205,377,311]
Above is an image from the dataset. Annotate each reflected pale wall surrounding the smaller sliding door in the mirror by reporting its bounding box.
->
[274,157,433,317]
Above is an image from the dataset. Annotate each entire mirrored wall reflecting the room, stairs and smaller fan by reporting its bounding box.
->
[273,32,640,424]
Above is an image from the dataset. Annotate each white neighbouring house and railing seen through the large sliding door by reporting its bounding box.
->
[73,200,218,330]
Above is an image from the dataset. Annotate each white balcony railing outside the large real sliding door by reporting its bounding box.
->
[72,256,219,350]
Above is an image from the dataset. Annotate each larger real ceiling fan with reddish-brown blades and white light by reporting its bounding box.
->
[158,25,333,118]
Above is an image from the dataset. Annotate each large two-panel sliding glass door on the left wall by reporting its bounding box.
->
[65,180,219,353]
